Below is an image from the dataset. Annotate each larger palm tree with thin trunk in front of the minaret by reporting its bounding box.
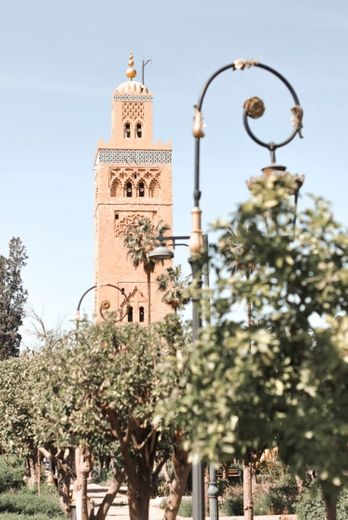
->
[124,217,169,324]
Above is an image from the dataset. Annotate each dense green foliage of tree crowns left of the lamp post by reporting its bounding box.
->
[0,315,187,516]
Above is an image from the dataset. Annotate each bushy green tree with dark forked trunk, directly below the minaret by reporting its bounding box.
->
[35,316,190,520]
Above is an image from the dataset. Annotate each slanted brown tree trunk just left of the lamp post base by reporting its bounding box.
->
[164,447,191,520]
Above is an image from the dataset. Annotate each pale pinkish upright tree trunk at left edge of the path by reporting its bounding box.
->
[74,446,92,520]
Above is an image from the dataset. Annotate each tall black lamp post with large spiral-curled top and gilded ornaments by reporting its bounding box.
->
[189,59,303,520]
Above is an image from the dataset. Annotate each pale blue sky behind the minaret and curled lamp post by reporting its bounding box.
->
[0,0,348,340]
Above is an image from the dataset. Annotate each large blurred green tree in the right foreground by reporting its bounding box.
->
[175,173,348,519]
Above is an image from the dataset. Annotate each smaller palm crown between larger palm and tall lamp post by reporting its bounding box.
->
[157,265,189,314]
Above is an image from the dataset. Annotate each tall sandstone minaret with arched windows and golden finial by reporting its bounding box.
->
[94,53,173,324]
